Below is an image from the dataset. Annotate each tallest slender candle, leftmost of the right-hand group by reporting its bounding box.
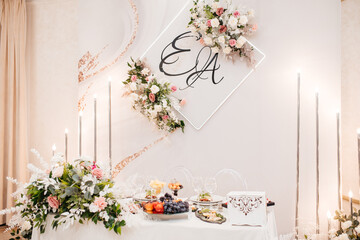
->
[295,71,301,239]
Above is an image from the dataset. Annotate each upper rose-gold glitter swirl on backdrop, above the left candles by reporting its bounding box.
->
[78,0,139,111]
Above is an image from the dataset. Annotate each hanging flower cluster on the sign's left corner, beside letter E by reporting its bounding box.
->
[123,59,186,132]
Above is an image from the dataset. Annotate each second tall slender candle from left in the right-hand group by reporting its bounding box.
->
[315,90,320,234]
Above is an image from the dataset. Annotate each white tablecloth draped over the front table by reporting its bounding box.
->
[32,207,278,240]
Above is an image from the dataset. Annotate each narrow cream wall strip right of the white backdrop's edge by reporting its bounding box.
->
[341,0,360,206]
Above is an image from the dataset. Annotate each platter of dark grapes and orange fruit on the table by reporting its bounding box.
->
[142,193,189,220]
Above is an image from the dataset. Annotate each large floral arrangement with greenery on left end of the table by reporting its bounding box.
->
[0,150,132,239]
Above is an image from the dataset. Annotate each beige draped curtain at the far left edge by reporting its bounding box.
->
[0,0,28,224]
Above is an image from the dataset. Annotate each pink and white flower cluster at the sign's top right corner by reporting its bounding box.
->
[188,0,257,65]
